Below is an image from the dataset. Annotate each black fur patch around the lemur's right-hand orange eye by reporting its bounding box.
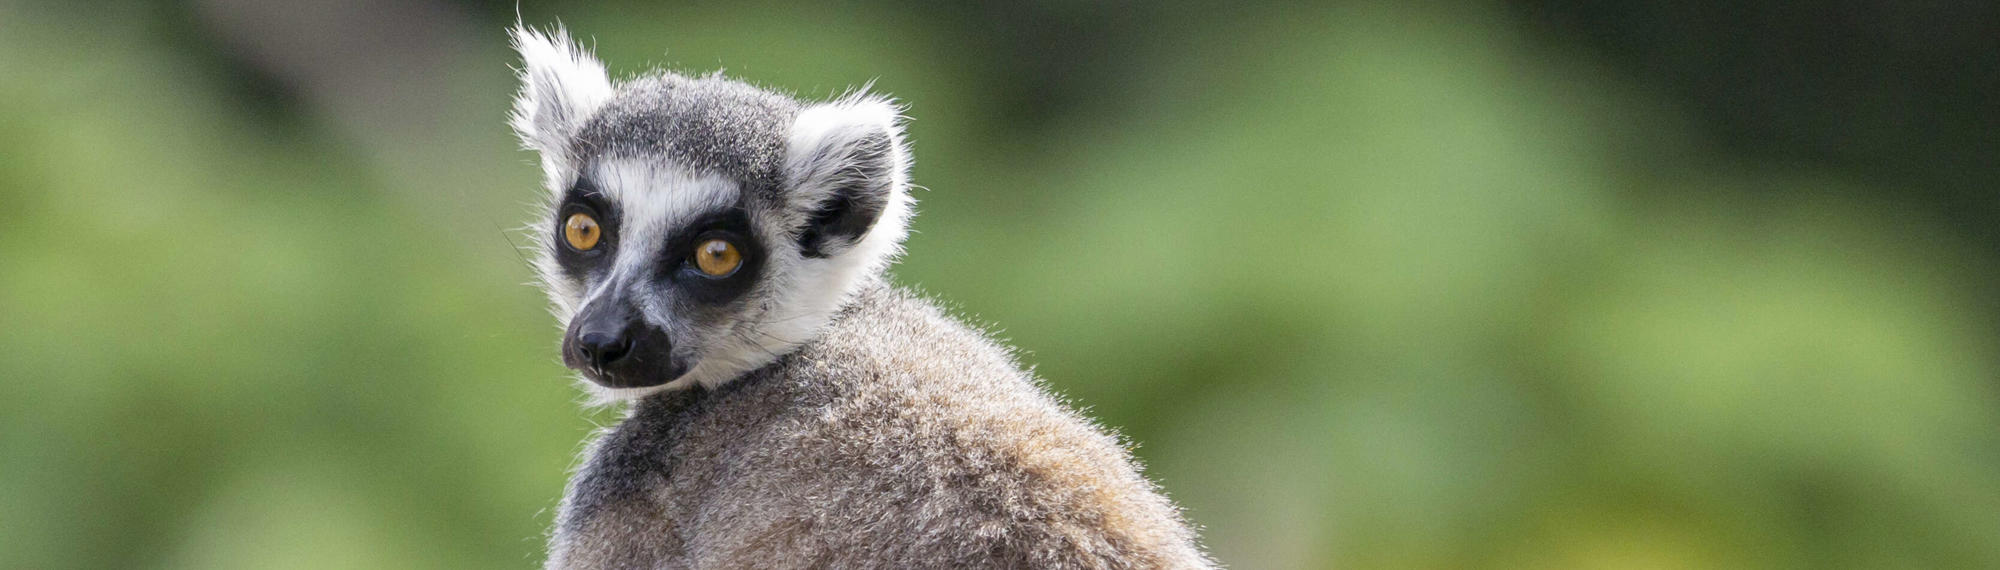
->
[656,208,766,304]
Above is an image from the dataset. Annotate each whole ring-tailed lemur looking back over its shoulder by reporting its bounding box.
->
[510,26,1214,570]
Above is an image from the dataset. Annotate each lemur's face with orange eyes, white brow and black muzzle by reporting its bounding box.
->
[548,158,782,388]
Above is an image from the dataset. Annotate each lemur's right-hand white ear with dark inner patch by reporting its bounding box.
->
[784,94,910,258]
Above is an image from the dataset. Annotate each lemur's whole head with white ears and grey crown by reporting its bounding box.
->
[512,28,912,400]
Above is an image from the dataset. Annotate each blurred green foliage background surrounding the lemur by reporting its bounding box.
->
[0,0,2000,568]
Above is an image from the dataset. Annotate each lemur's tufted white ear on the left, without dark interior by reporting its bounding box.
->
[508,24,612,166]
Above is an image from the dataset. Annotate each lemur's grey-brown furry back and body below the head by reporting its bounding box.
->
[548,284,1210,568]
